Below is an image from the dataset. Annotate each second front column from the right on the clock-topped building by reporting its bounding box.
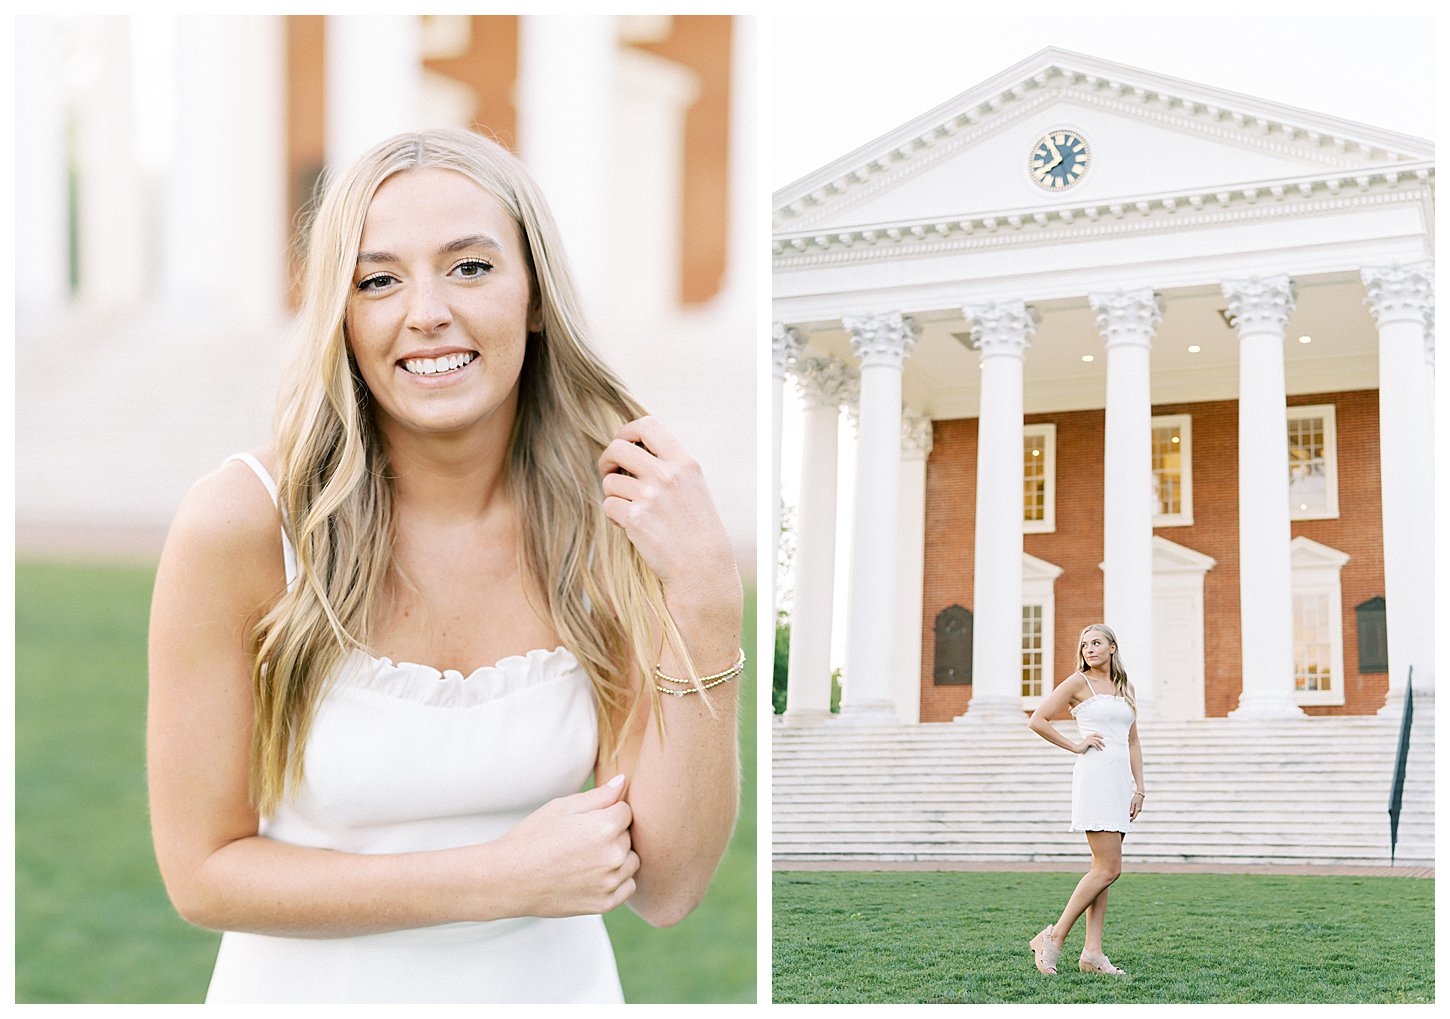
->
[1224,275,1304,719]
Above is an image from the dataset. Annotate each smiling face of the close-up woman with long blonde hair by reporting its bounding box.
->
[347,170,538,435]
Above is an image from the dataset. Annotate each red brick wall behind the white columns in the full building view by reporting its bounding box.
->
[921,390,1388,722]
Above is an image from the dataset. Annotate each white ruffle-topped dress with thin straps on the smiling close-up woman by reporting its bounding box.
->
[206,455,624,1003]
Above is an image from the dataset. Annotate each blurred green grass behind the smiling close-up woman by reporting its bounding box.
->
[15,562,755,1003]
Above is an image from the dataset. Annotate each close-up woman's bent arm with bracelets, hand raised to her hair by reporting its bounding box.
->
[599,417,742,926]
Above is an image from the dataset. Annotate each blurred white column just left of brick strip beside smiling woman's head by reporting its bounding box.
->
[161,16,289,320]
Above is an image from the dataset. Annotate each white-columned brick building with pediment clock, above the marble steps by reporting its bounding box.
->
[771,49,1436,725]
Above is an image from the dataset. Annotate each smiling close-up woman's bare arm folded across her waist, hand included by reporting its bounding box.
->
[146,464,637,936]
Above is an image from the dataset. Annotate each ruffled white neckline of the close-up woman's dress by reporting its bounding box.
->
[334,646,587,707]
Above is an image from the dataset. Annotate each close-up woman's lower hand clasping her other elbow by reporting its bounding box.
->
[487,775,639,916]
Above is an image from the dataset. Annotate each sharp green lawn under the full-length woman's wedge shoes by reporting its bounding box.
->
[773,860,1434,1003]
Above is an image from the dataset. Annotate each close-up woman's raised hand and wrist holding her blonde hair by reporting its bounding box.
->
[599,417,740,615]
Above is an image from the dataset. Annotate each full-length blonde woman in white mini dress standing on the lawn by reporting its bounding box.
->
[1028,623,1144,976]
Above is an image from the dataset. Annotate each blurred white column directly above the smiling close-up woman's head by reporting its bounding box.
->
[323,14,423,168]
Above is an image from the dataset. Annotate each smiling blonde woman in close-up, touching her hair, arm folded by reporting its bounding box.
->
[148,130,742,1002]
